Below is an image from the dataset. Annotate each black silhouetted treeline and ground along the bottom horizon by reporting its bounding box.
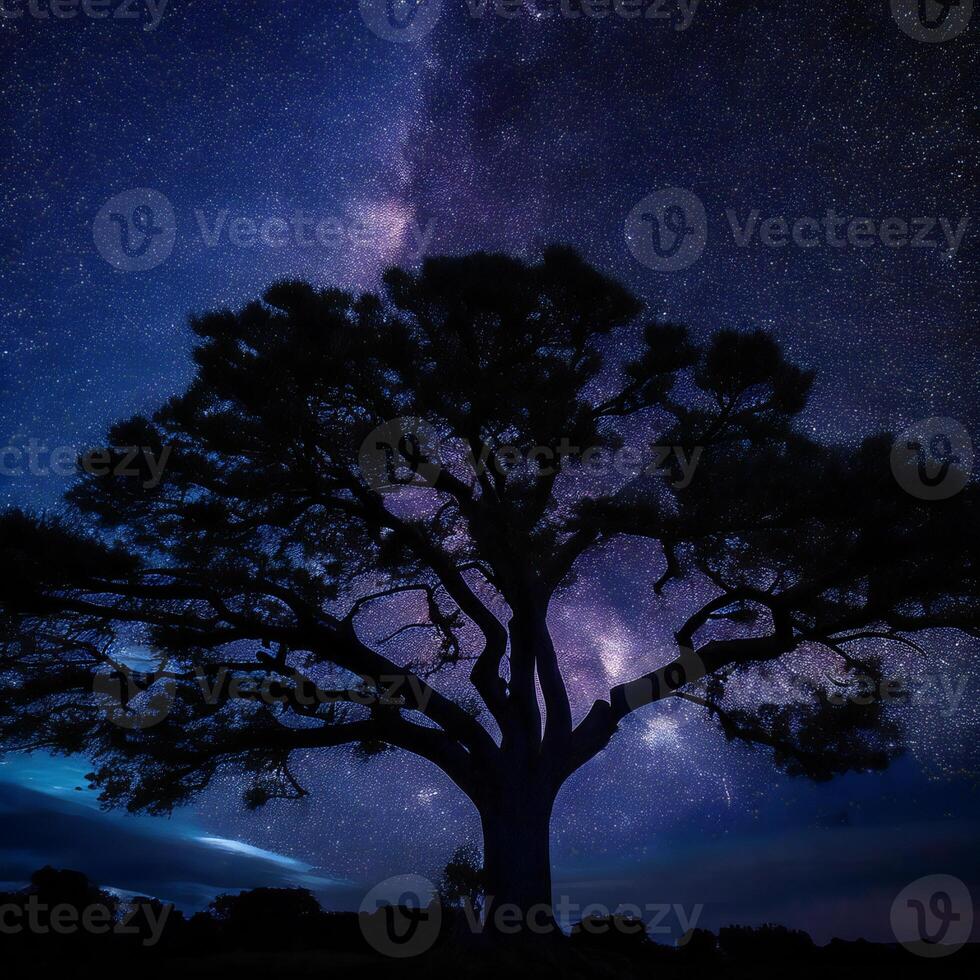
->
[0,867,980,980]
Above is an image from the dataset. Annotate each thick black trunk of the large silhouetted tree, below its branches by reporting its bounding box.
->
[480,785,557,938]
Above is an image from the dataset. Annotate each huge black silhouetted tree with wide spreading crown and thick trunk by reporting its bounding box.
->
[0,248,980,936]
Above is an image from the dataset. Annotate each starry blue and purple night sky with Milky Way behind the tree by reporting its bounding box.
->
[0,0,980,941]
